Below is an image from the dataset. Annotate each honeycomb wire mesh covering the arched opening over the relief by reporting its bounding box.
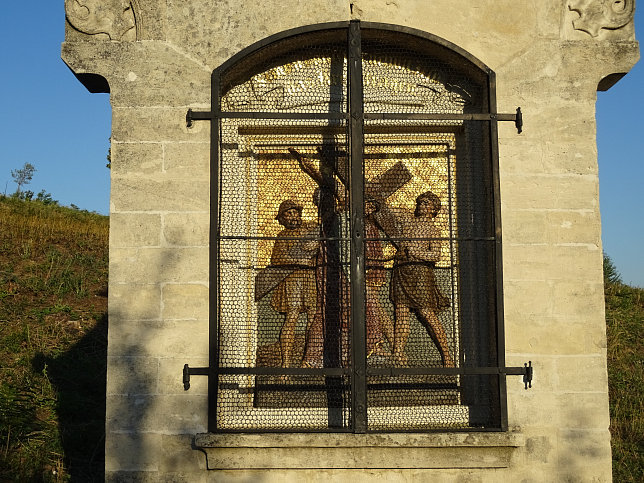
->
[211,22,499,431]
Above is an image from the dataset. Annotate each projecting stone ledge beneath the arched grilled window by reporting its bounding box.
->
[194,433,525,470]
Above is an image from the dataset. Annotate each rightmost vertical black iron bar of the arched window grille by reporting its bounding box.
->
[488,71,508,431]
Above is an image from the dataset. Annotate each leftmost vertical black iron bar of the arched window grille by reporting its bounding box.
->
[208,70,221,433]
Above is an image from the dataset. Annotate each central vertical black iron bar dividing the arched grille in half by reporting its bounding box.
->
[348,20,367,433]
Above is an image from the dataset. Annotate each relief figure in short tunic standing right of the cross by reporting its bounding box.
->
[390,191,454,367]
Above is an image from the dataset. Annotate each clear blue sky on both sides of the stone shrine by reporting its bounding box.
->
[0,0,644,287]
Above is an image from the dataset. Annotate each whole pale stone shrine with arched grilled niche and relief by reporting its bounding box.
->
[62,0,639,482]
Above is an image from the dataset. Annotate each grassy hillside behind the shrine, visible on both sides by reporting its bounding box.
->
[0,197,644,482]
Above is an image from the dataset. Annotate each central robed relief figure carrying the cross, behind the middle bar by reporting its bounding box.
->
[289,148,411,366]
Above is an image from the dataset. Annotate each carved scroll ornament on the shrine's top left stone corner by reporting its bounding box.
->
[65,0,138,40]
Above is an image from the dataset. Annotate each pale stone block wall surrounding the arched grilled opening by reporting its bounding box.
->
[61,0,639,482]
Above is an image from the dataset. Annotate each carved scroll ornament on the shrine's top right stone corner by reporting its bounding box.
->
[568,0,635,37]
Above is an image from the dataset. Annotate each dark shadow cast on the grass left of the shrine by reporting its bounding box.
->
[33,313,107,482]
